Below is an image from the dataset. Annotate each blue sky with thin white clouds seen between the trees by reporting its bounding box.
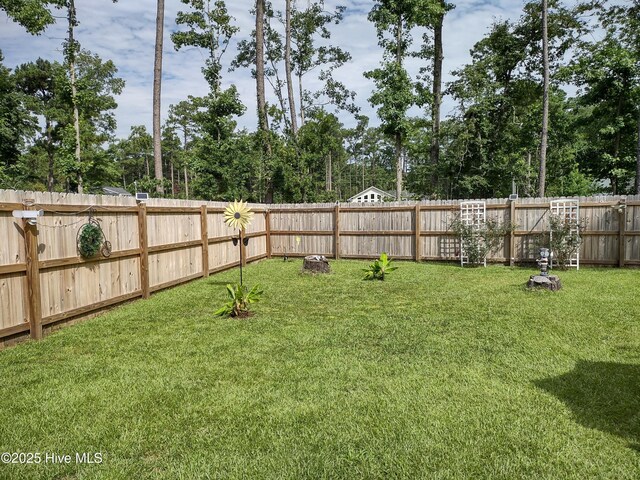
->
[0,0,524,138]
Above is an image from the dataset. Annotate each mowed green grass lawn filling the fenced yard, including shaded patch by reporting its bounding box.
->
[0,260,640,480]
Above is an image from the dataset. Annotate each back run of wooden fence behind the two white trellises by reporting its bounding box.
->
[269,196,640,266]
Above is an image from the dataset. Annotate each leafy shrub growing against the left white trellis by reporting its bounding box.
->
[451,218,515,265]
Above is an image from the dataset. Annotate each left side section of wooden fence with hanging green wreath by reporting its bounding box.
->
[0,190,268,342]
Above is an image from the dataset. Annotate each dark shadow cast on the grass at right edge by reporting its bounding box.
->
[534,360,640,451]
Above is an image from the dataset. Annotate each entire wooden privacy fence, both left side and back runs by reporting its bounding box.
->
[0,190,640,342]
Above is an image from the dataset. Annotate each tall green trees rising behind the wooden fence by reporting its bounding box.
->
[0,0,640,202]
